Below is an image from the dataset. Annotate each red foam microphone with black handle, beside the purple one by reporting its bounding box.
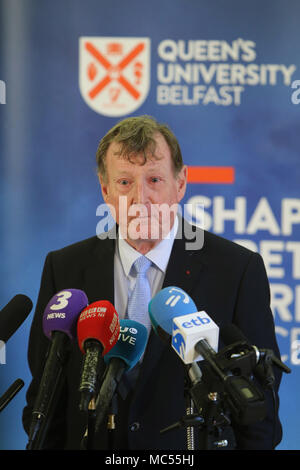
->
[77,300,120,411]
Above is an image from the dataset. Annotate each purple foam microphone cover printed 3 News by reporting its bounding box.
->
[43,289,89,340]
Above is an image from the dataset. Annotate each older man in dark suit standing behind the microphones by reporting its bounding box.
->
[23,116,281,450]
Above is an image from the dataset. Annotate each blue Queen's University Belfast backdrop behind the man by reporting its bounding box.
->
[0,0,300,449]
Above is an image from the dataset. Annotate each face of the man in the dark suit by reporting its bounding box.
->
[100,134,186,252]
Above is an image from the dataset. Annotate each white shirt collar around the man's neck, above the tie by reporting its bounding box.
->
[118,217,178,276]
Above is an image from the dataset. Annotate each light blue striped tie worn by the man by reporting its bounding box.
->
[127,256,151,332]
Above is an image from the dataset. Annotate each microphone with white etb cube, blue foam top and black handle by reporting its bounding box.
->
[149,291,265,424]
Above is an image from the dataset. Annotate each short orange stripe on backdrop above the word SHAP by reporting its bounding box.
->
[188,166,235,184]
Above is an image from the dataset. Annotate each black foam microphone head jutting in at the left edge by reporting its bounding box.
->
[0,294,33,343]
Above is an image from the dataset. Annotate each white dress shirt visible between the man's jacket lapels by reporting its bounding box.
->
[114,217,178,318]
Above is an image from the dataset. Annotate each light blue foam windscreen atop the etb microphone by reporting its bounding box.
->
[148,286,197,342]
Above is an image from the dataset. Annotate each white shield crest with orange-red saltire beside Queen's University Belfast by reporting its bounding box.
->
[79,37,150,116]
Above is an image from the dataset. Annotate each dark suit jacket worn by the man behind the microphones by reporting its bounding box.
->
[23,222,282,450]
